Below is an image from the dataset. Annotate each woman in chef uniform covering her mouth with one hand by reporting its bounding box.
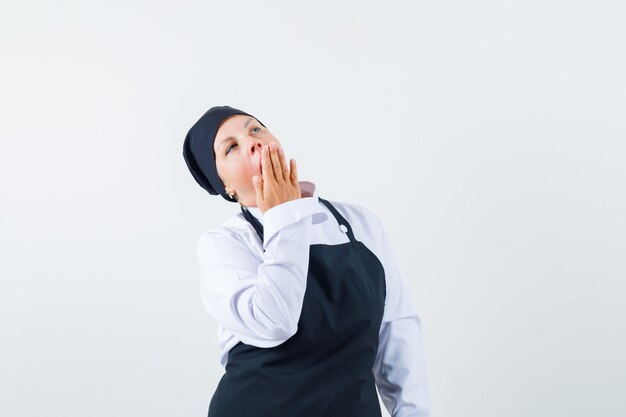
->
[183,106,430,417]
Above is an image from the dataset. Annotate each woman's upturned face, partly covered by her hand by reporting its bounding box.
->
[213,114,280,207]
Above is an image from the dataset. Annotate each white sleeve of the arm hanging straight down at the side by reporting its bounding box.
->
[373,216,430,417]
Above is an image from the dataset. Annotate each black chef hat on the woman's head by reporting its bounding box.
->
[183,106,265,202]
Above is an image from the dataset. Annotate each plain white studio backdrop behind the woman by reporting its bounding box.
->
[0,0,626,417]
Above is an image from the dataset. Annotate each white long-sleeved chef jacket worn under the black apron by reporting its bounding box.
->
[197,181,430,417]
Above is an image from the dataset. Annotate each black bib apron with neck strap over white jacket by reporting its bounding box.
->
[208,197,386,417]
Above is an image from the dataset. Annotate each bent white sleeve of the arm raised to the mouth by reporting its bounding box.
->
[196,197,327,347]
